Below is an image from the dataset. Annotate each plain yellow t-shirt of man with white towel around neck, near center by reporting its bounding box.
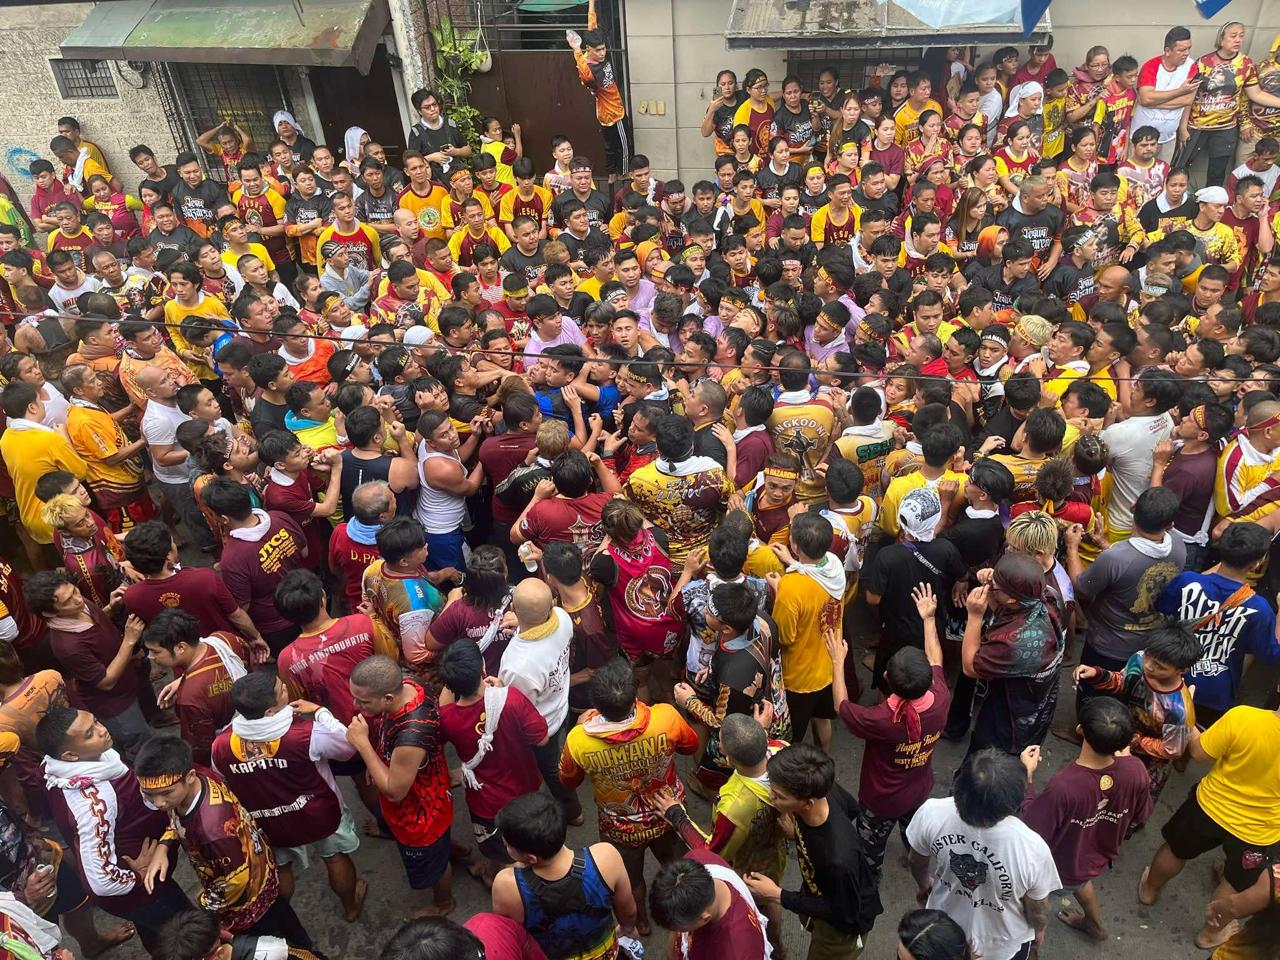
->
[773,568,845,694]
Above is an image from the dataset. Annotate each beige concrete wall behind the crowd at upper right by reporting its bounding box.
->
[626,0,1280,186]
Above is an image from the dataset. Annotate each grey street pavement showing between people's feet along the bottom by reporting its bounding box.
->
[90,624,1274,960]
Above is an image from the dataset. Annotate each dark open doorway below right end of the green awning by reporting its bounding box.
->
[311,44,404,166]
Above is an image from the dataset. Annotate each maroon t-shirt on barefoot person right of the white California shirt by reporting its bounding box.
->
[1023,756,1151,887]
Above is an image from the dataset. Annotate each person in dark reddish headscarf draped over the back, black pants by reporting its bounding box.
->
[961,553,1066,756]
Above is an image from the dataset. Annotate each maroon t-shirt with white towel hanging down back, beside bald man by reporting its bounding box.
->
[440,686,547,820]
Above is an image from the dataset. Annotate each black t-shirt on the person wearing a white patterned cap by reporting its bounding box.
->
[863,540,969,650]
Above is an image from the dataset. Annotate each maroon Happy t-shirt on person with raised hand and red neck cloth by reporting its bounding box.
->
[840,667,951,819]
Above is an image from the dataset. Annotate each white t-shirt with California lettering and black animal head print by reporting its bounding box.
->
[906,797,1062,960]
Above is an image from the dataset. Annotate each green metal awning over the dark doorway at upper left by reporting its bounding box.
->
[61,0,390,73]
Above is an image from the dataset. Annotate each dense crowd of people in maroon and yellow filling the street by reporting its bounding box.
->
[0,6,1280,960]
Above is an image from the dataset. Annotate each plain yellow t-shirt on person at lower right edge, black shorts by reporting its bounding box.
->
[1196,707,1280,846]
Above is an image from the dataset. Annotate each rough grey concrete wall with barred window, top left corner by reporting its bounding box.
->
[0,4,174,206]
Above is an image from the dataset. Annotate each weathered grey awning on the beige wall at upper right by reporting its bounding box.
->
[724,0,1050,50]
